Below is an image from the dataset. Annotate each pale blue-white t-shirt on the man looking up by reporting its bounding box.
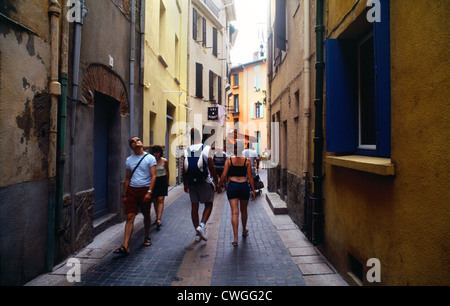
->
[126,153,156,188]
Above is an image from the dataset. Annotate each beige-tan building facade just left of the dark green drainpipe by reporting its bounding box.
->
[267,0,315,228]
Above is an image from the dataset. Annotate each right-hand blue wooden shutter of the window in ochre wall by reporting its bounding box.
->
[374,0,391,157]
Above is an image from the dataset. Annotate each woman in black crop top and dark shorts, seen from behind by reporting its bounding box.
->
[219,140,255,246]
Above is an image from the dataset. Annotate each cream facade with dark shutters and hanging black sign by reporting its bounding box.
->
[186,0,236,139]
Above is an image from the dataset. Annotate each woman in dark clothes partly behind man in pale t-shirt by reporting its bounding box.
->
[150,146,170,230]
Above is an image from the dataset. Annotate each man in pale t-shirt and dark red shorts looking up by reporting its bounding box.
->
[114,137,156,255]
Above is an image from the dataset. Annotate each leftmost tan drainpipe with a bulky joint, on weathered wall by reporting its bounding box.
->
[46,0,61,271]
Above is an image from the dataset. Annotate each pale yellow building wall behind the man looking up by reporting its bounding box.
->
[143,0,188,185]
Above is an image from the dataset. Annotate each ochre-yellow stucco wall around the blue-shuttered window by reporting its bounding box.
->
[322,0,450,285]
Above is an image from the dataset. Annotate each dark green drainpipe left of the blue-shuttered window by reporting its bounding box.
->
[311,0,325,245]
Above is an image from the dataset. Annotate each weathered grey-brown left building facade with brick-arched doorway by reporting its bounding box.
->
[0,0,143,285]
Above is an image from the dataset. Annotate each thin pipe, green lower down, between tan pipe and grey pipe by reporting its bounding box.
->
[56,0,69,233]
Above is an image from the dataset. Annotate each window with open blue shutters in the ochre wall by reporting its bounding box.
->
[325,0,391,157]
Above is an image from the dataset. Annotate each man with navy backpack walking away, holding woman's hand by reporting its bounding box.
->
[182,129,221,241]
